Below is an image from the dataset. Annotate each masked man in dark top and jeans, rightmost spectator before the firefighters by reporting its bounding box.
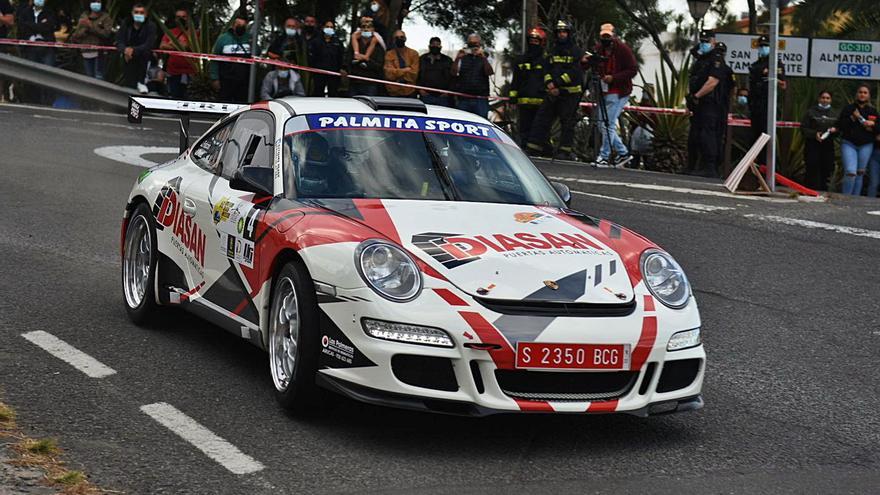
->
[452,33,495,118]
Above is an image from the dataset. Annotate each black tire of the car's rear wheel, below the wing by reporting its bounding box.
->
[120,203,159,326]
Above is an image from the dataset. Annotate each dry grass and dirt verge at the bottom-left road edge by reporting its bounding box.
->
[0,402,107,495]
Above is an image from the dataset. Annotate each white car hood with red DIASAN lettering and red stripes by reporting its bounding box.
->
[321,200,638,304]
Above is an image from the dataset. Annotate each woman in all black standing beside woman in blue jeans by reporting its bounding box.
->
[801,90,837,191]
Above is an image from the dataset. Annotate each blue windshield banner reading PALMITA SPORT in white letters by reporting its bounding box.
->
[306,113,500,140]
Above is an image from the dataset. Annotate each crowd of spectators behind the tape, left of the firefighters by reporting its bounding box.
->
[0,0,493,117]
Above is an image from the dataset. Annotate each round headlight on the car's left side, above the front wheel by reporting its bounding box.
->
[355,239,422,302]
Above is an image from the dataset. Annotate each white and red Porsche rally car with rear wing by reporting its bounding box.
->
[122,97,705,416]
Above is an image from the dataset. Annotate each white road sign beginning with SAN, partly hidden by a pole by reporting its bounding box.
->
[715,33,810,77]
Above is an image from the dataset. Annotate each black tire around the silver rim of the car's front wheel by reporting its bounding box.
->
[268,260,325,415]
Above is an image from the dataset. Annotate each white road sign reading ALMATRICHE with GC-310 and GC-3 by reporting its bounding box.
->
[810,38,880,80]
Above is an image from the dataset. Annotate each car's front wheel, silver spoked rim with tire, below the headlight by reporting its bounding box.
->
[269,261,322,413]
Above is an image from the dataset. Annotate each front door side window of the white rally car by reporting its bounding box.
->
[220,110,275,181]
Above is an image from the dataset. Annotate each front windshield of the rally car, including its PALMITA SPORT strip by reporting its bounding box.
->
[284,114,564,207]
